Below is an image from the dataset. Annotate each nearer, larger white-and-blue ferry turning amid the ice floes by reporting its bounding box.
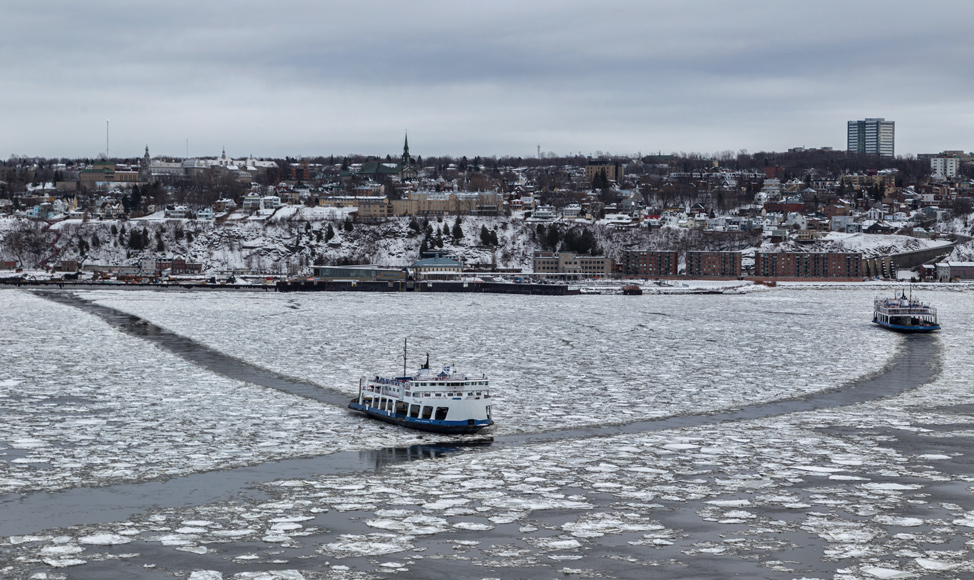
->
[348,346,494,434]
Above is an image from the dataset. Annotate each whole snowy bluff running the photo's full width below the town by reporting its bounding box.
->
[0,211,960,274]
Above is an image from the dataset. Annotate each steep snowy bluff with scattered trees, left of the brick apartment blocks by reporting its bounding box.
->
[0,208,548,273]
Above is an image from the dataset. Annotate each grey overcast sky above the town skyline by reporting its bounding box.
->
[0,0,974,157]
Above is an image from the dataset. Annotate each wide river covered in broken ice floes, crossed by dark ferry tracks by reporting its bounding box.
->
[0,286,974,580]
